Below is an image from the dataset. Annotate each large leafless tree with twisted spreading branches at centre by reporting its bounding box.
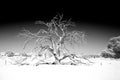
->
[19,15,85,64]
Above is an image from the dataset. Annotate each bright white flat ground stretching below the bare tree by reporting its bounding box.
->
[0,53,120,80]
